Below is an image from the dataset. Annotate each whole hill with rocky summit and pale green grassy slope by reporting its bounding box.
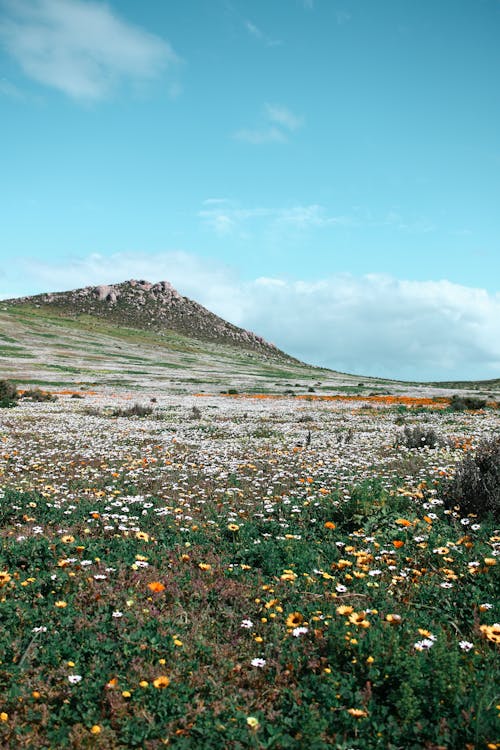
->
[0,280,344,392]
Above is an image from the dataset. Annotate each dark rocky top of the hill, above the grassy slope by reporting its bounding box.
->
[3,279,297,362]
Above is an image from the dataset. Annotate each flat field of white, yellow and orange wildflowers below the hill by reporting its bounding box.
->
[0,390,500,750]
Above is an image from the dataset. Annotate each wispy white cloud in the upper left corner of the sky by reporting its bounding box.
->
[0,0,179,101]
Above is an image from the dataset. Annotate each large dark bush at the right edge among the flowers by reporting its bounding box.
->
[442,436,500,521]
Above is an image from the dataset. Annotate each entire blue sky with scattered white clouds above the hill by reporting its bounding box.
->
[0,0,500,380]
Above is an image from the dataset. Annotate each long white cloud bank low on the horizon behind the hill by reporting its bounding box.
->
[0,251,500,380]
